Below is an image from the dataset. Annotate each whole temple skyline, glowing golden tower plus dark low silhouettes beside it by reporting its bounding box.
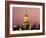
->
[13,10,40,31]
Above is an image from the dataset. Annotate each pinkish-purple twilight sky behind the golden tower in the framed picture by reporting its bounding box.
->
[13,7,40,25]
